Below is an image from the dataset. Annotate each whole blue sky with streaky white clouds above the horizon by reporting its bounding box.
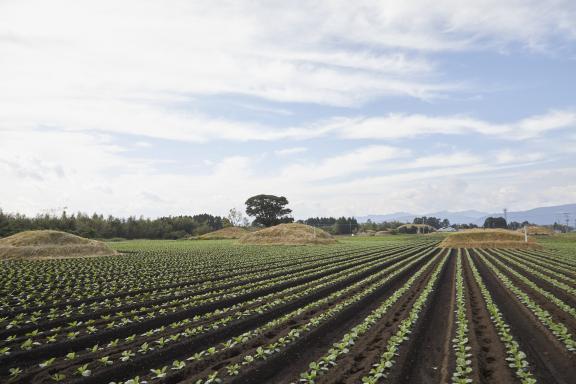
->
[0,0,576,218]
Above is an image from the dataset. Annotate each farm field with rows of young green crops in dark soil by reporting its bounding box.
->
[0,236,576,384]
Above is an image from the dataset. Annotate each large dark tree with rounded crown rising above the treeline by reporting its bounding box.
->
[246,195,294,227]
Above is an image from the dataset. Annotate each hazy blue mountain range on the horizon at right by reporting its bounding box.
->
[356,204,576,225]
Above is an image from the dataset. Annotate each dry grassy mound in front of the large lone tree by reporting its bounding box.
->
[240,224,336,245]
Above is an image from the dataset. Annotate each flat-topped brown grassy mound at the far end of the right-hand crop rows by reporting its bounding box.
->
[440,229,540,249]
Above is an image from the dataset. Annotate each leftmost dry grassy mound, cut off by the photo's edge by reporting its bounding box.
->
[0,231,116,259]
